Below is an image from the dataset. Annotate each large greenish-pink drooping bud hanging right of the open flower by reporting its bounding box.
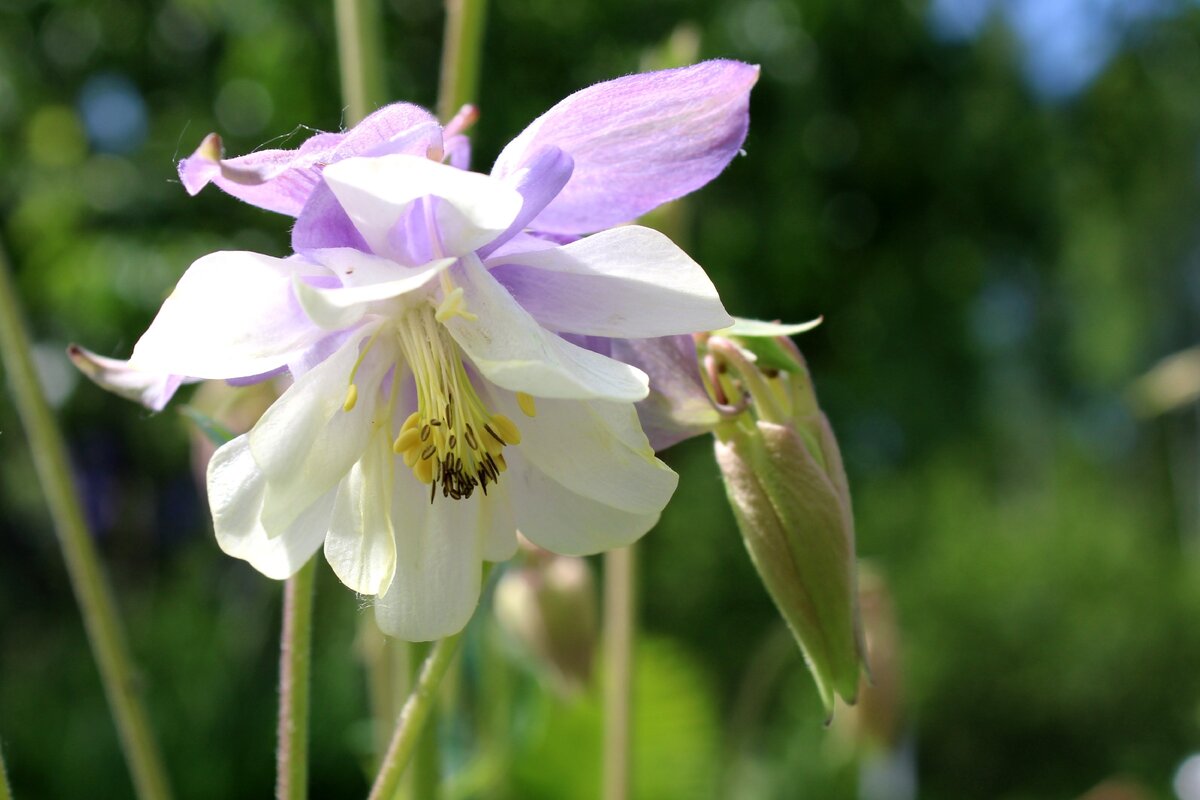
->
[701,323,865,715]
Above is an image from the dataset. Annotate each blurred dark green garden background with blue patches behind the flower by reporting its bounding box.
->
[0,0,1200,800]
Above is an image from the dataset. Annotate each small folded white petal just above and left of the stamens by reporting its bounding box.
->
[294,256,456,330]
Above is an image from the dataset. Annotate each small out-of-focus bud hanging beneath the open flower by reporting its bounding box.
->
[494,537,598,692]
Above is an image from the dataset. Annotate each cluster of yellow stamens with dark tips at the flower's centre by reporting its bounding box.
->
[392,303,532,503]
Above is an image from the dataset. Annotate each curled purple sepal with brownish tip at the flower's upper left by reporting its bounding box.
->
[179,103,442,217]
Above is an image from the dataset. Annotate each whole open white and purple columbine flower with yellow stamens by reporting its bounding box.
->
[77,62,757,639]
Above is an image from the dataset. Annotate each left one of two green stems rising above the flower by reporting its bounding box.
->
[334,0,386,126]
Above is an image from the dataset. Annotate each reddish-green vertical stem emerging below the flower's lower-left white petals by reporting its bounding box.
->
[275,558,317,800]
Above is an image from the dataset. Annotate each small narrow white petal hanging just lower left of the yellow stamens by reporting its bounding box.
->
[325,432,403,595]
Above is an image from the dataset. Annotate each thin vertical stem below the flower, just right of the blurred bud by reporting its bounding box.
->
[604,546,636,800]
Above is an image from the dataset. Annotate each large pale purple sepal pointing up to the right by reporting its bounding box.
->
[492,61,758,233]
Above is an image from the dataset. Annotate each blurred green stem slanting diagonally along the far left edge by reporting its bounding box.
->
[0,247,170,800]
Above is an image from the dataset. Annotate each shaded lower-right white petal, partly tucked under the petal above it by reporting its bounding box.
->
[502,447,659,555]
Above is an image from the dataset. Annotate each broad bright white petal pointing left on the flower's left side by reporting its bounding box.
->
[130,252,328,378]
